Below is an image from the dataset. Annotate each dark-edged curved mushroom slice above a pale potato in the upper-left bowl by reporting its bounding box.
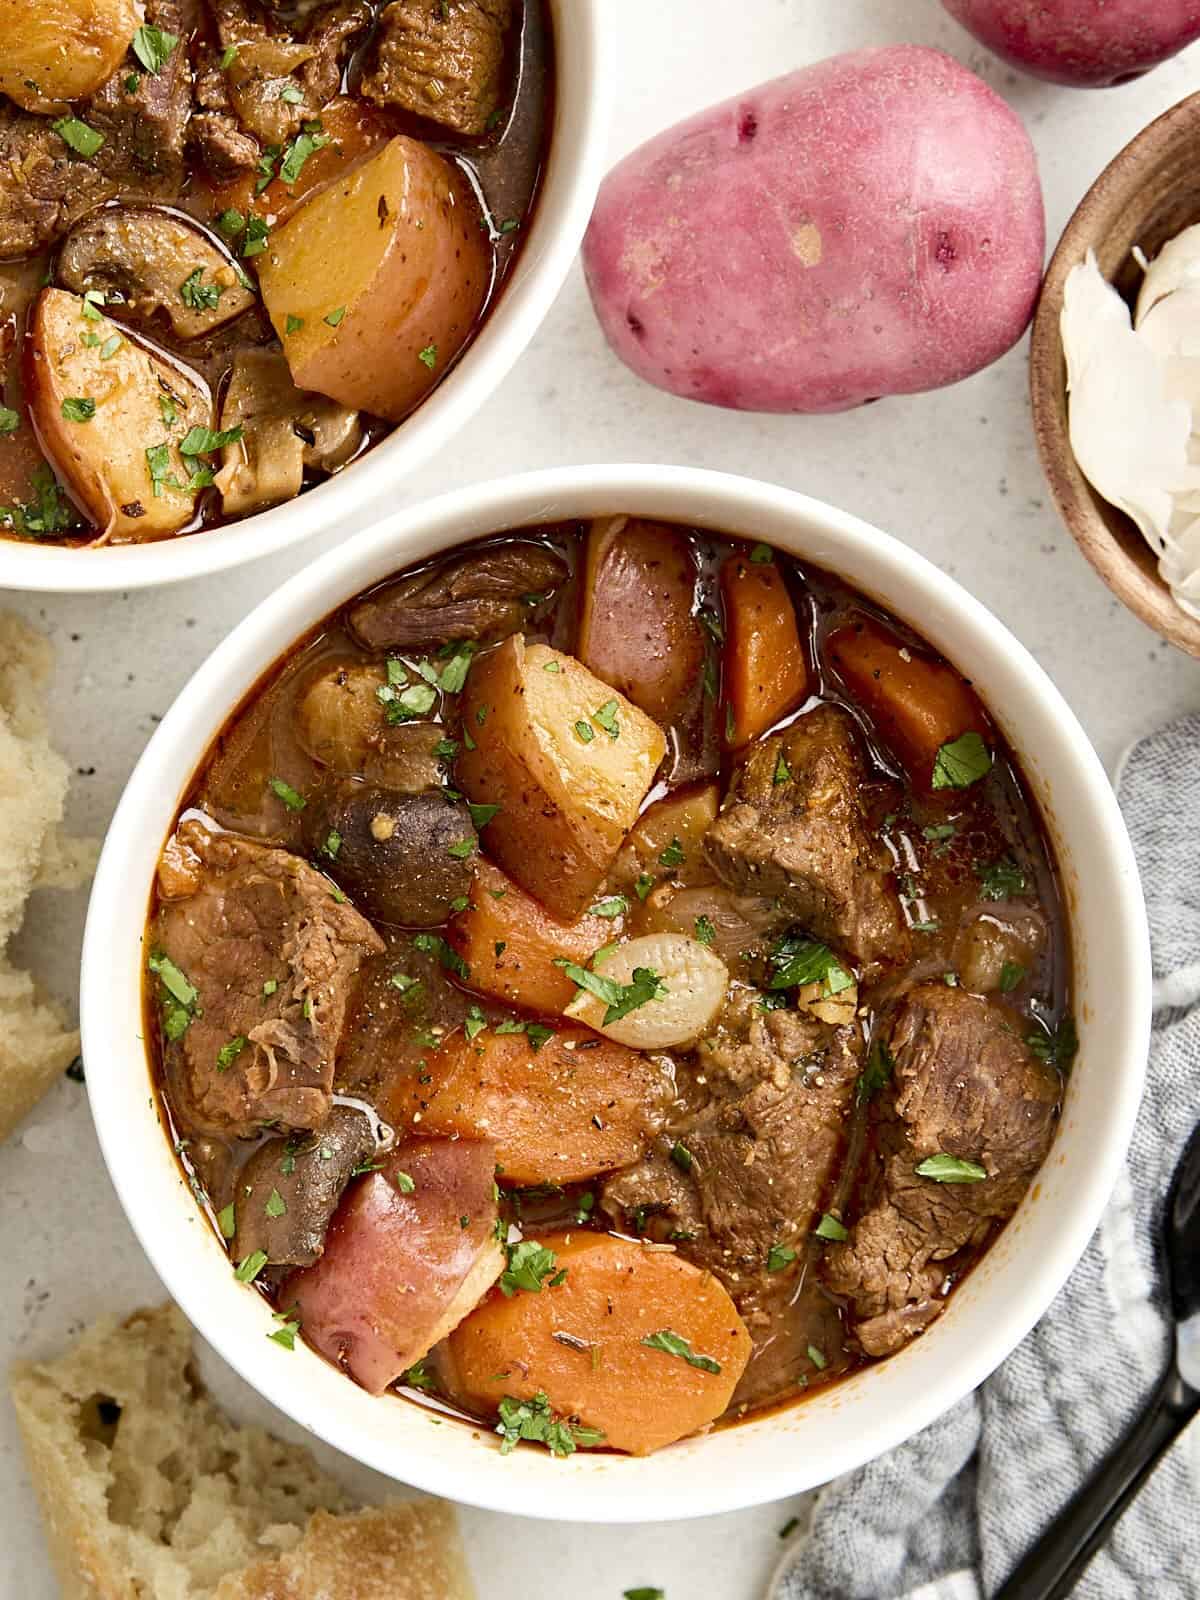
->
[58,205,256,339]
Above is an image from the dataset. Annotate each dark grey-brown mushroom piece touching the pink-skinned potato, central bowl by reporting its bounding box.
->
[234,1106,376,1267]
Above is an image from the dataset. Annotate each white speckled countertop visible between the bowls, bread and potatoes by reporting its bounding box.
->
[0,0,1200,1600]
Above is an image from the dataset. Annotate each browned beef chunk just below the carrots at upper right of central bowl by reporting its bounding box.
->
[704,706,910,976]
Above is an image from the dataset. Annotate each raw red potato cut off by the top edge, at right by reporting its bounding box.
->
[942,0,1200,88]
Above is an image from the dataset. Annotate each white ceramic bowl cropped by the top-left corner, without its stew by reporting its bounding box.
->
[0,0,613,594]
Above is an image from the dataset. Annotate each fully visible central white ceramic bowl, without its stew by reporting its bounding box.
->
[82,466,1150,1522]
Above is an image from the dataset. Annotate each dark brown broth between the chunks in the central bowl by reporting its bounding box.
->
[146,523,1070,1446]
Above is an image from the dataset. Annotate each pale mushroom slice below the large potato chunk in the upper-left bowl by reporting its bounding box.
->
[216,350,363,517]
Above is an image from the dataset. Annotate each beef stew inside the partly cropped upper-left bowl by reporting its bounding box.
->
[0,0,554,546]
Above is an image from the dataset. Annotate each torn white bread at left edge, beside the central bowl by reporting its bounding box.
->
[0,614,96,1139]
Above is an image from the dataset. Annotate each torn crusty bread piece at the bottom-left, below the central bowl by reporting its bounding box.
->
[11,1306,474,1600]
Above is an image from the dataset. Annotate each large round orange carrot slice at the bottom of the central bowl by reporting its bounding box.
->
[443,1230,750,1456]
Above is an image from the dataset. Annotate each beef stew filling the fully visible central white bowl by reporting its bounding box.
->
[147,517,1075,1454]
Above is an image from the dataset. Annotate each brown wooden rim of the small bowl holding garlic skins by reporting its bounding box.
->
[1029,91,1200,656]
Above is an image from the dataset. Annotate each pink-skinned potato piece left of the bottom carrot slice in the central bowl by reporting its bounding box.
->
[280,1139,504,1394]
